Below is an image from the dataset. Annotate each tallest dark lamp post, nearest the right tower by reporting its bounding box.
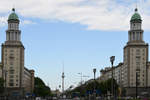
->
[110,56,115,99]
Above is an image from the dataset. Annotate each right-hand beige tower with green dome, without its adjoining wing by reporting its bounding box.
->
[122,8,148,96]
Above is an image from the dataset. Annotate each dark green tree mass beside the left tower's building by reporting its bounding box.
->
[34,77,51,97]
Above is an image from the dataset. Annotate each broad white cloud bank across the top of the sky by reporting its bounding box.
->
[0,0,150,30]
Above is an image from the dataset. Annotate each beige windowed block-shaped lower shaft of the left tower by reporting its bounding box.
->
[2,41,24,88]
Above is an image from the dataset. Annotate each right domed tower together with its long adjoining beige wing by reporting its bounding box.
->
[100,8,150,96]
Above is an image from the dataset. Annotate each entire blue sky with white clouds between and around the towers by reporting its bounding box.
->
[0,0,150,89]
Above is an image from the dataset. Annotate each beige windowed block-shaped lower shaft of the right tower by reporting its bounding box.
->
[124,43,148,87]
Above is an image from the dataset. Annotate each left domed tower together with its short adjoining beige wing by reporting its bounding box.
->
[1,9,34,95]
